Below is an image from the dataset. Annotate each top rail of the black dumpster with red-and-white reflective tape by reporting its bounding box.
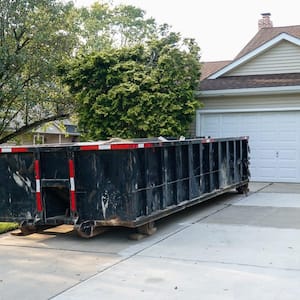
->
[0,136,249,154]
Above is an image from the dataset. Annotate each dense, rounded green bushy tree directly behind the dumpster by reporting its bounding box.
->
[64,33,200,139]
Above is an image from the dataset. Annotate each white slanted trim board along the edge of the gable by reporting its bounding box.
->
[208,33,300,79]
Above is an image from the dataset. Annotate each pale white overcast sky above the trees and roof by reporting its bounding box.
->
[74,0,300,61]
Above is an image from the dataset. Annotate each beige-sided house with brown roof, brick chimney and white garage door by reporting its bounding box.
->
[195,13,300,183]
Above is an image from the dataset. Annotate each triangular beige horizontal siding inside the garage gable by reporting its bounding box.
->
[224,41,300,76]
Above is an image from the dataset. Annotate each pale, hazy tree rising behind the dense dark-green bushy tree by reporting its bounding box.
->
[80,2,157,52]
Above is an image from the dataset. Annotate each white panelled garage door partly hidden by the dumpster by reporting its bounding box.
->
[199,112,300,182]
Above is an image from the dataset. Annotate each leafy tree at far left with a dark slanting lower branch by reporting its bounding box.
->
[0,0,78,143]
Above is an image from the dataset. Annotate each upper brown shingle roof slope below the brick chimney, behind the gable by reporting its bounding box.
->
[234,25,300,60]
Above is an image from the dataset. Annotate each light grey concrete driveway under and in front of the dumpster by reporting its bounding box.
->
[0,183,300,300]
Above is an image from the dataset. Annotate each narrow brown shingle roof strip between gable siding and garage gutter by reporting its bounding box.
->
[200,73,300,91]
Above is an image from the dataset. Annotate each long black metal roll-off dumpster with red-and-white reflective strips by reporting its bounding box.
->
[0,137,249,237]
